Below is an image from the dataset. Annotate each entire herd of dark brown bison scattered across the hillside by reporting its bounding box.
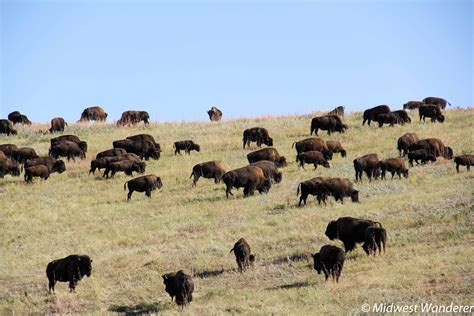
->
[0,97,474,305]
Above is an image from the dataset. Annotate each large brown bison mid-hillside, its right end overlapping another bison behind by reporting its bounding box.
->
[222,166,272,198]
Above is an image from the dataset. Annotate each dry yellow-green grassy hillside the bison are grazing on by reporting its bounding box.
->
[0,109,474,315]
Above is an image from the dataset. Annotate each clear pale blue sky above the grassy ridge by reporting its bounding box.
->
[0,0,474,122]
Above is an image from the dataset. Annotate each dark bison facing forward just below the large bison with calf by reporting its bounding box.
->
[313,245,346,282]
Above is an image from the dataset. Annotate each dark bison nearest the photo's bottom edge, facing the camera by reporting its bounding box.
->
[162,270,194,306]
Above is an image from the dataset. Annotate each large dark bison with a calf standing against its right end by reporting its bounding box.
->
[325,217,382,253]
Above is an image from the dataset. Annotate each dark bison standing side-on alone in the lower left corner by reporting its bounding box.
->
[46,255,92,293]
